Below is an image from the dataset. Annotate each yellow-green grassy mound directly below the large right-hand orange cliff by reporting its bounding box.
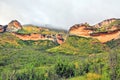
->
[48,36,104,55]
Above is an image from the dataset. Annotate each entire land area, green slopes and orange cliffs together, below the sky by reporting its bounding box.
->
[0,19,120,80]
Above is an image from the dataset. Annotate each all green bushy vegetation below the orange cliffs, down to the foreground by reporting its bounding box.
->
[0,33,120,80]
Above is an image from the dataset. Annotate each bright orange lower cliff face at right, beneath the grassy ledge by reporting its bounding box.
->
[69,25,120,43]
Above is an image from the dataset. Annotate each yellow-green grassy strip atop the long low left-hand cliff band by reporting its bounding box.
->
[17,25,67,36]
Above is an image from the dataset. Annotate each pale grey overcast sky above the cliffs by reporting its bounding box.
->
[0,0,120,29]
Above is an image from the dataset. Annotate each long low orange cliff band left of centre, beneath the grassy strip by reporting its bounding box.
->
[12,33,64,44]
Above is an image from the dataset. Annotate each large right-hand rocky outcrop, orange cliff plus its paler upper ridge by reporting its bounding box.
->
[69,18,120,43]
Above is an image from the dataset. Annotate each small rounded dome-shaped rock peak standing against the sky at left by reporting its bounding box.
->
[7,20,22,32]
